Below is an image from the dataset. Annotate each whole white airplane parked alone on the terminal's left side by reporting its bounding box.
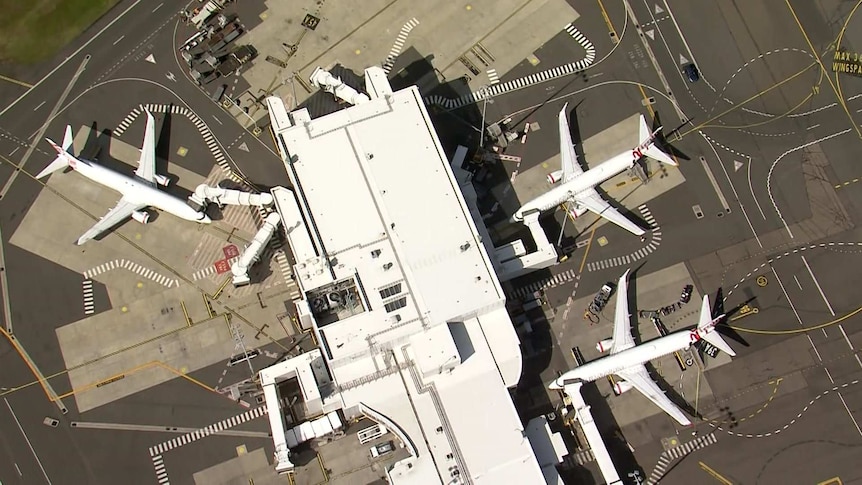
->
[36,110,212,246]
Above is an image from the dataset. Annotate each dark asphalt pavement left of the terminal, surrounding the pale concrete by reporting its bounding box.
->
[0,0,287,484]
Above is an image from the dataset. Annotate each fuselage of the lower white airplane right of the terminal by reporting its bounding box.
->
[554,328,714,389]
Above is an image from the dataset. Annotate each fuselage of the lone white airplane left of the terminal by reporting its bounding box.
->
[73,158,206,222]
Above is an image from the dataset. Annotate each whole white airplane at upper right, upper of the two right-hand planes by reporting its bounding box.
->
[512,103,677,236]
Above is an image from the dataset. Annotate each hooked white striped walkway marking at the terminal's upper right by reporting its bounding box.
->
[425,23,600,110]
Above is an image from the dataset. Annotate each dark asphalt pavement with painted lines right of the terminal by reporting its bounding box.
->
[488,1,862,483]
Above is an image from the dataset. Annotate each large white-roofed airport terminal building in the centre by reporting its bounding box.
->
[253,68,566,485]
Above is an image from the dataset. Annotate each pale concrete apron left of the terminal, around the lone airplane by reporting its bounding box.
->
[10,127,298,412]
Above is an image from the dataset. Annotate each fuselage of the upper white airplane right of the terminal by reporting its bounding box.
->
[512,147,637,221]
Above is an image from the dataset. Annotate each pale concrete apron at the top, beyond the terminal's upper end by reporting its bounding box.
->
[229,0,579,125]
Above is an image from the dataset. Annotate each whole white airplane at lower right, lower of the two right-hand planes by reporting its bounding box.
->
[548,271,736,426]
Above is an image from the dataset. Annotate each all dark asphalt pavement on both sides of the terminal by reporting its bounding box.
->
[0,0,862,484]
